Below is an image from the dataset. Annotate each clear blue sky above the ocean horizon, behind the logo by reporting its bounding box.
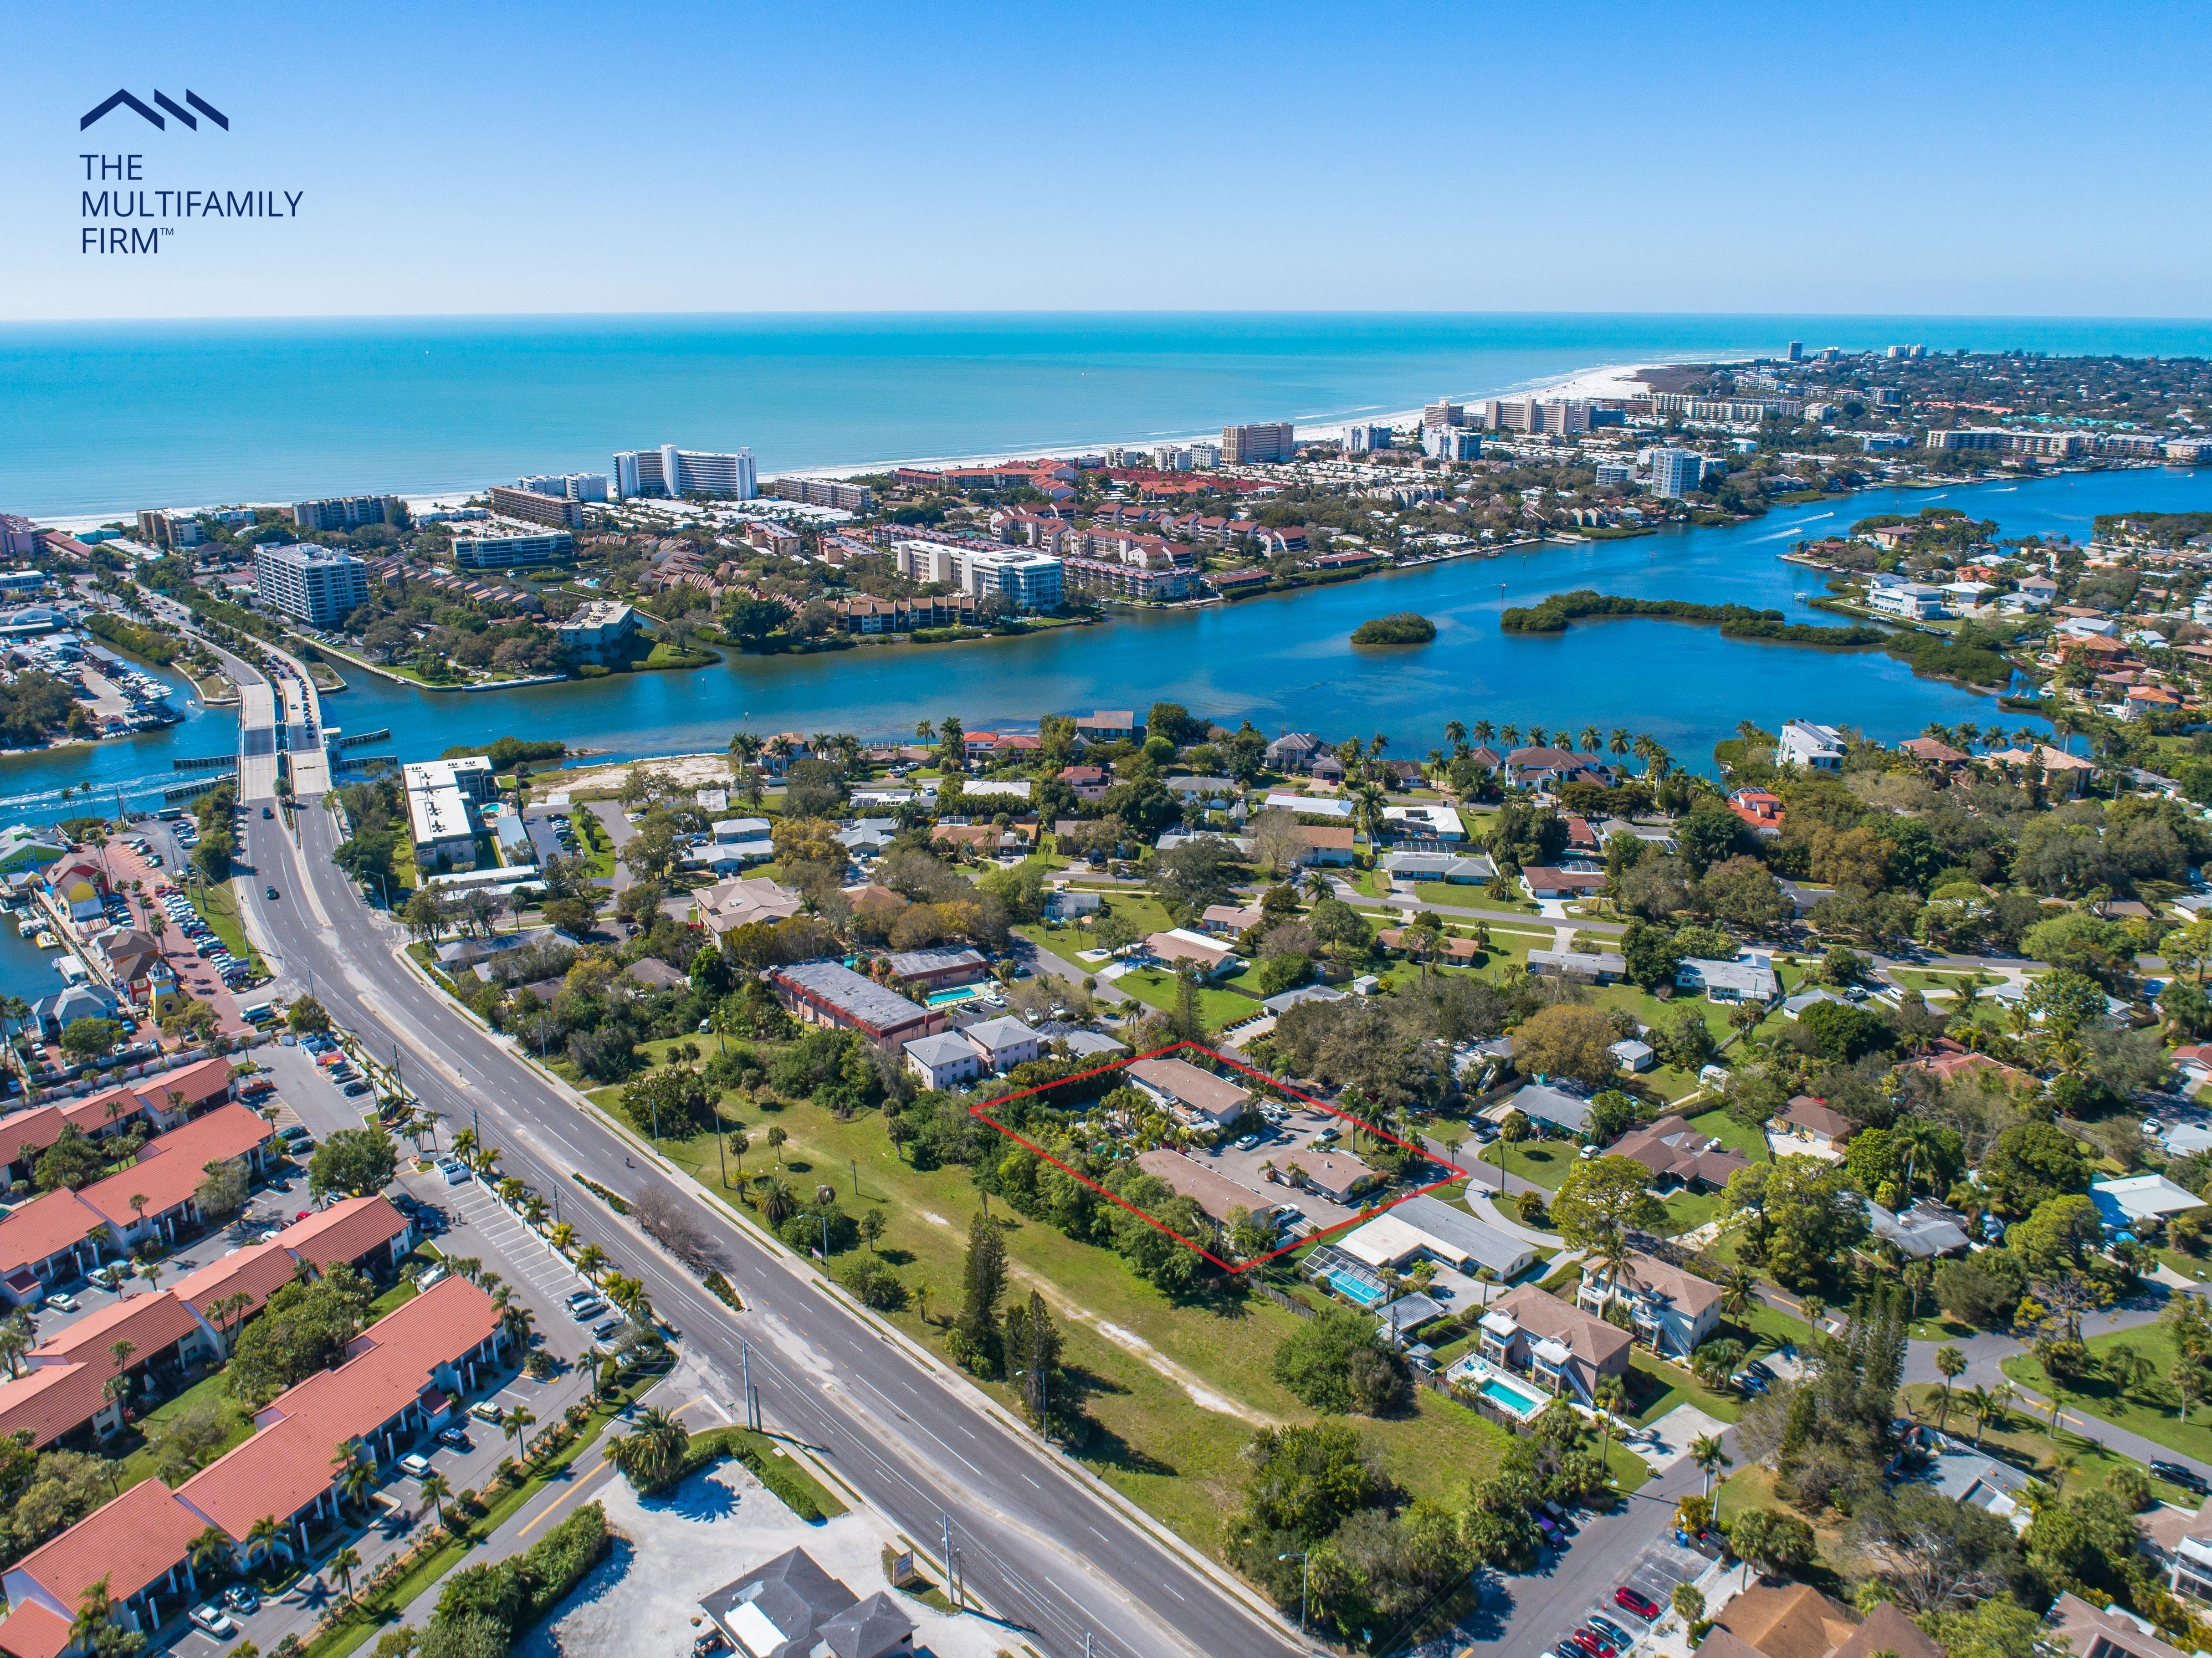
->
[17,0,2212,318]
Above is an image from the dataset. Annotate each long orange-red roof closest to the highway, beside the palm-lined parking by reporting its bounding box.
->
[177,1278,500,1541]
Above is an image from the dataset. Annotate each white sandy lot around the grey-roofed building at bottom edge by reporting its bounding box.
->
[515,1461,1018,1658]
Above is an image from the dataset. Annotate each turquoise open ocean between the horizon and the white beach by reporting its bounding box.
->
[13,314,2212,517]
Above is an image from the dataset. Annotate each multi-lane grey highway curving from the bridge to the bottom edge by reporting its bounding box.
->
[199,641,1301,1658]
